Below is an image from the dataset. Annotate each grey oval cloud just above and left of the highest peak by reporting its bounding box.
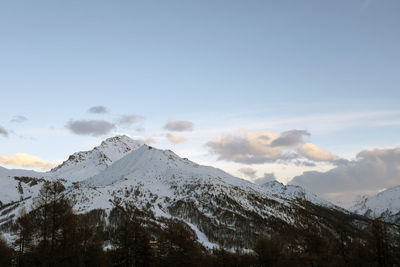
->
[65,120,115,136]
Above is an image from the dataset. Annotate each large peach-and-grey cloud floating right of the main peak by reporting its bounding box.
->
[206,130,324,164]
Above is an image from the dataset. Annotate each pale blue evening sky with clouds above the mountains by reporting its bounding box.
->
[0,0,400,206]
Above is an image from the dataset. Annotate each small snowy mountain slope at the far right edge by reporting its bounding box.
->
[350,186,400,224]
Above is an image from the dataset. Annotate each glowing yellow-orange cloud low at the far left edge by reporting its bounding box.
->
[0,153,60,169]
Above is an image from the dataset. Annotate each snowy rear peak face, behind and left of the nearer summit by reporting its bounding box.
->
[49,135,141,182]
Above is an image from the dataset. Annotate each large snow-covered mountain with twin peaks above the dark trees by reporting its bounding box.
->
[0,136,366,248]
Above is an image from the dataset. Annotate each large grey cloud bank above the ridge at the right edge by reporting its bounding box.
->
[290,147,400,207]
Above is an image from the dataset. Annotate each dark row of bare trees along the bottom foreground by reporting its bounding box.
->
[0,182,400,267]
